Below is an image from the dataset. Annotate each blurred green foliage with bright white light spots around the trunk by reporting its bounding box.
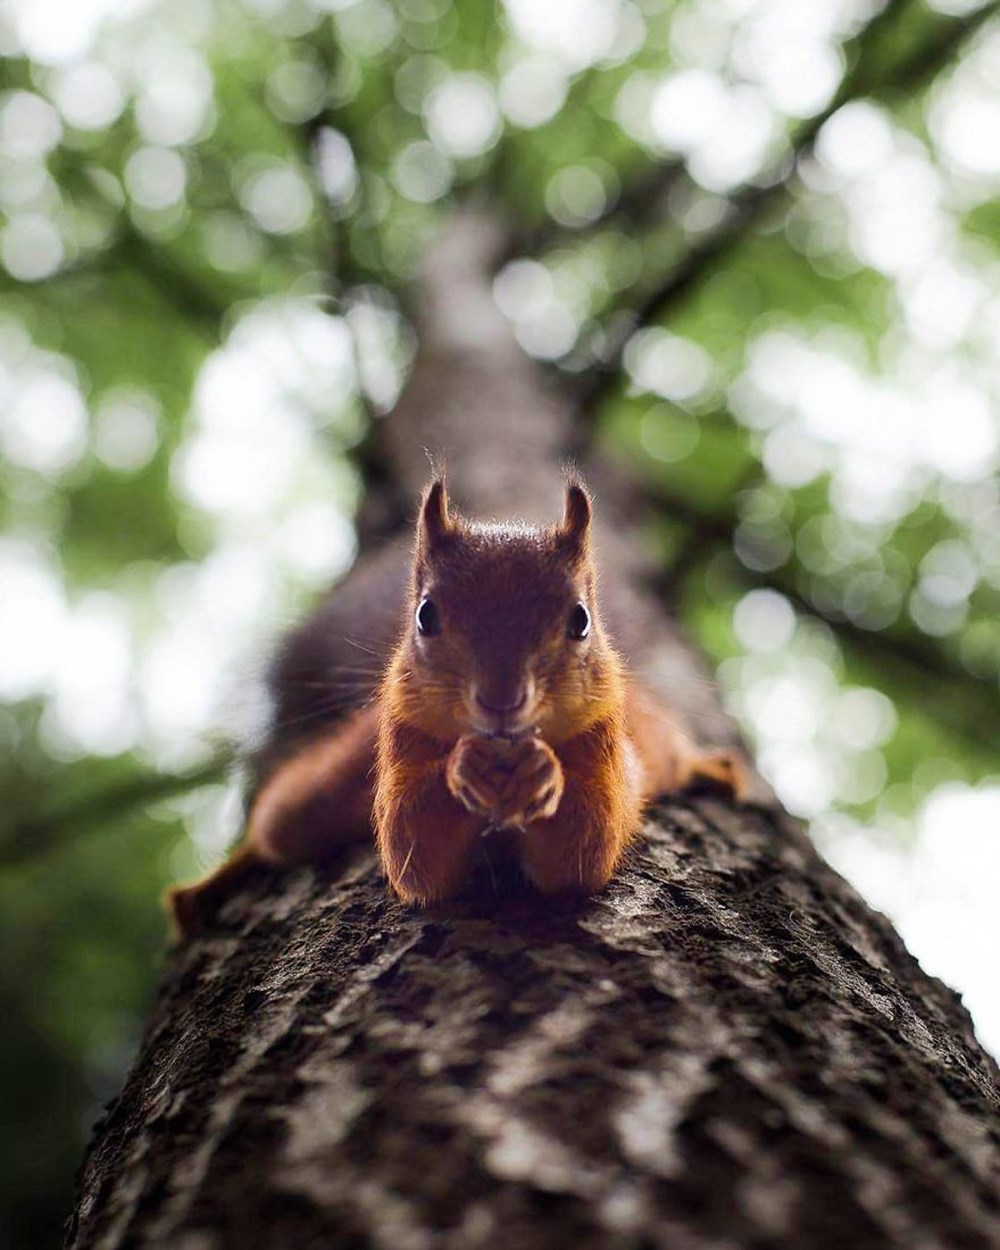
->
[0,0,1000,1246]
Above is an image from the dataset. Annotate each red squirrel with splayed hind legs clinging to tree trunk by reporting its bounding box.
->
[170,479,744,933]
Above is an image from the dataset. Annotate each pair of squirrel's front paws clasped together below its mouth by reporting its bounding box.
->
[445,734,564,828]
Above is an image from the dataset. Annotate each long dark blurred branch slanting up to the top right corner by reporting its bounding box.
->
[581,0,1000,413]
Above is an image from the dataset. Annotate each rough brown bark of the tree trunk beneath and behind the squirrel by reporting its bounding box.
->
[68,218,1000,1250]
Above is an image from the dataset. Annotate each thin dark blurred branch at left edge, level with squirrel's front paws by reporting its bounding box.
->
[0,756,233,868]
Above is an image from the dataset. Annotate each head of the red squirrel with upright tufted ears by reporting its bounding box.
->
[393,478,621,741]
